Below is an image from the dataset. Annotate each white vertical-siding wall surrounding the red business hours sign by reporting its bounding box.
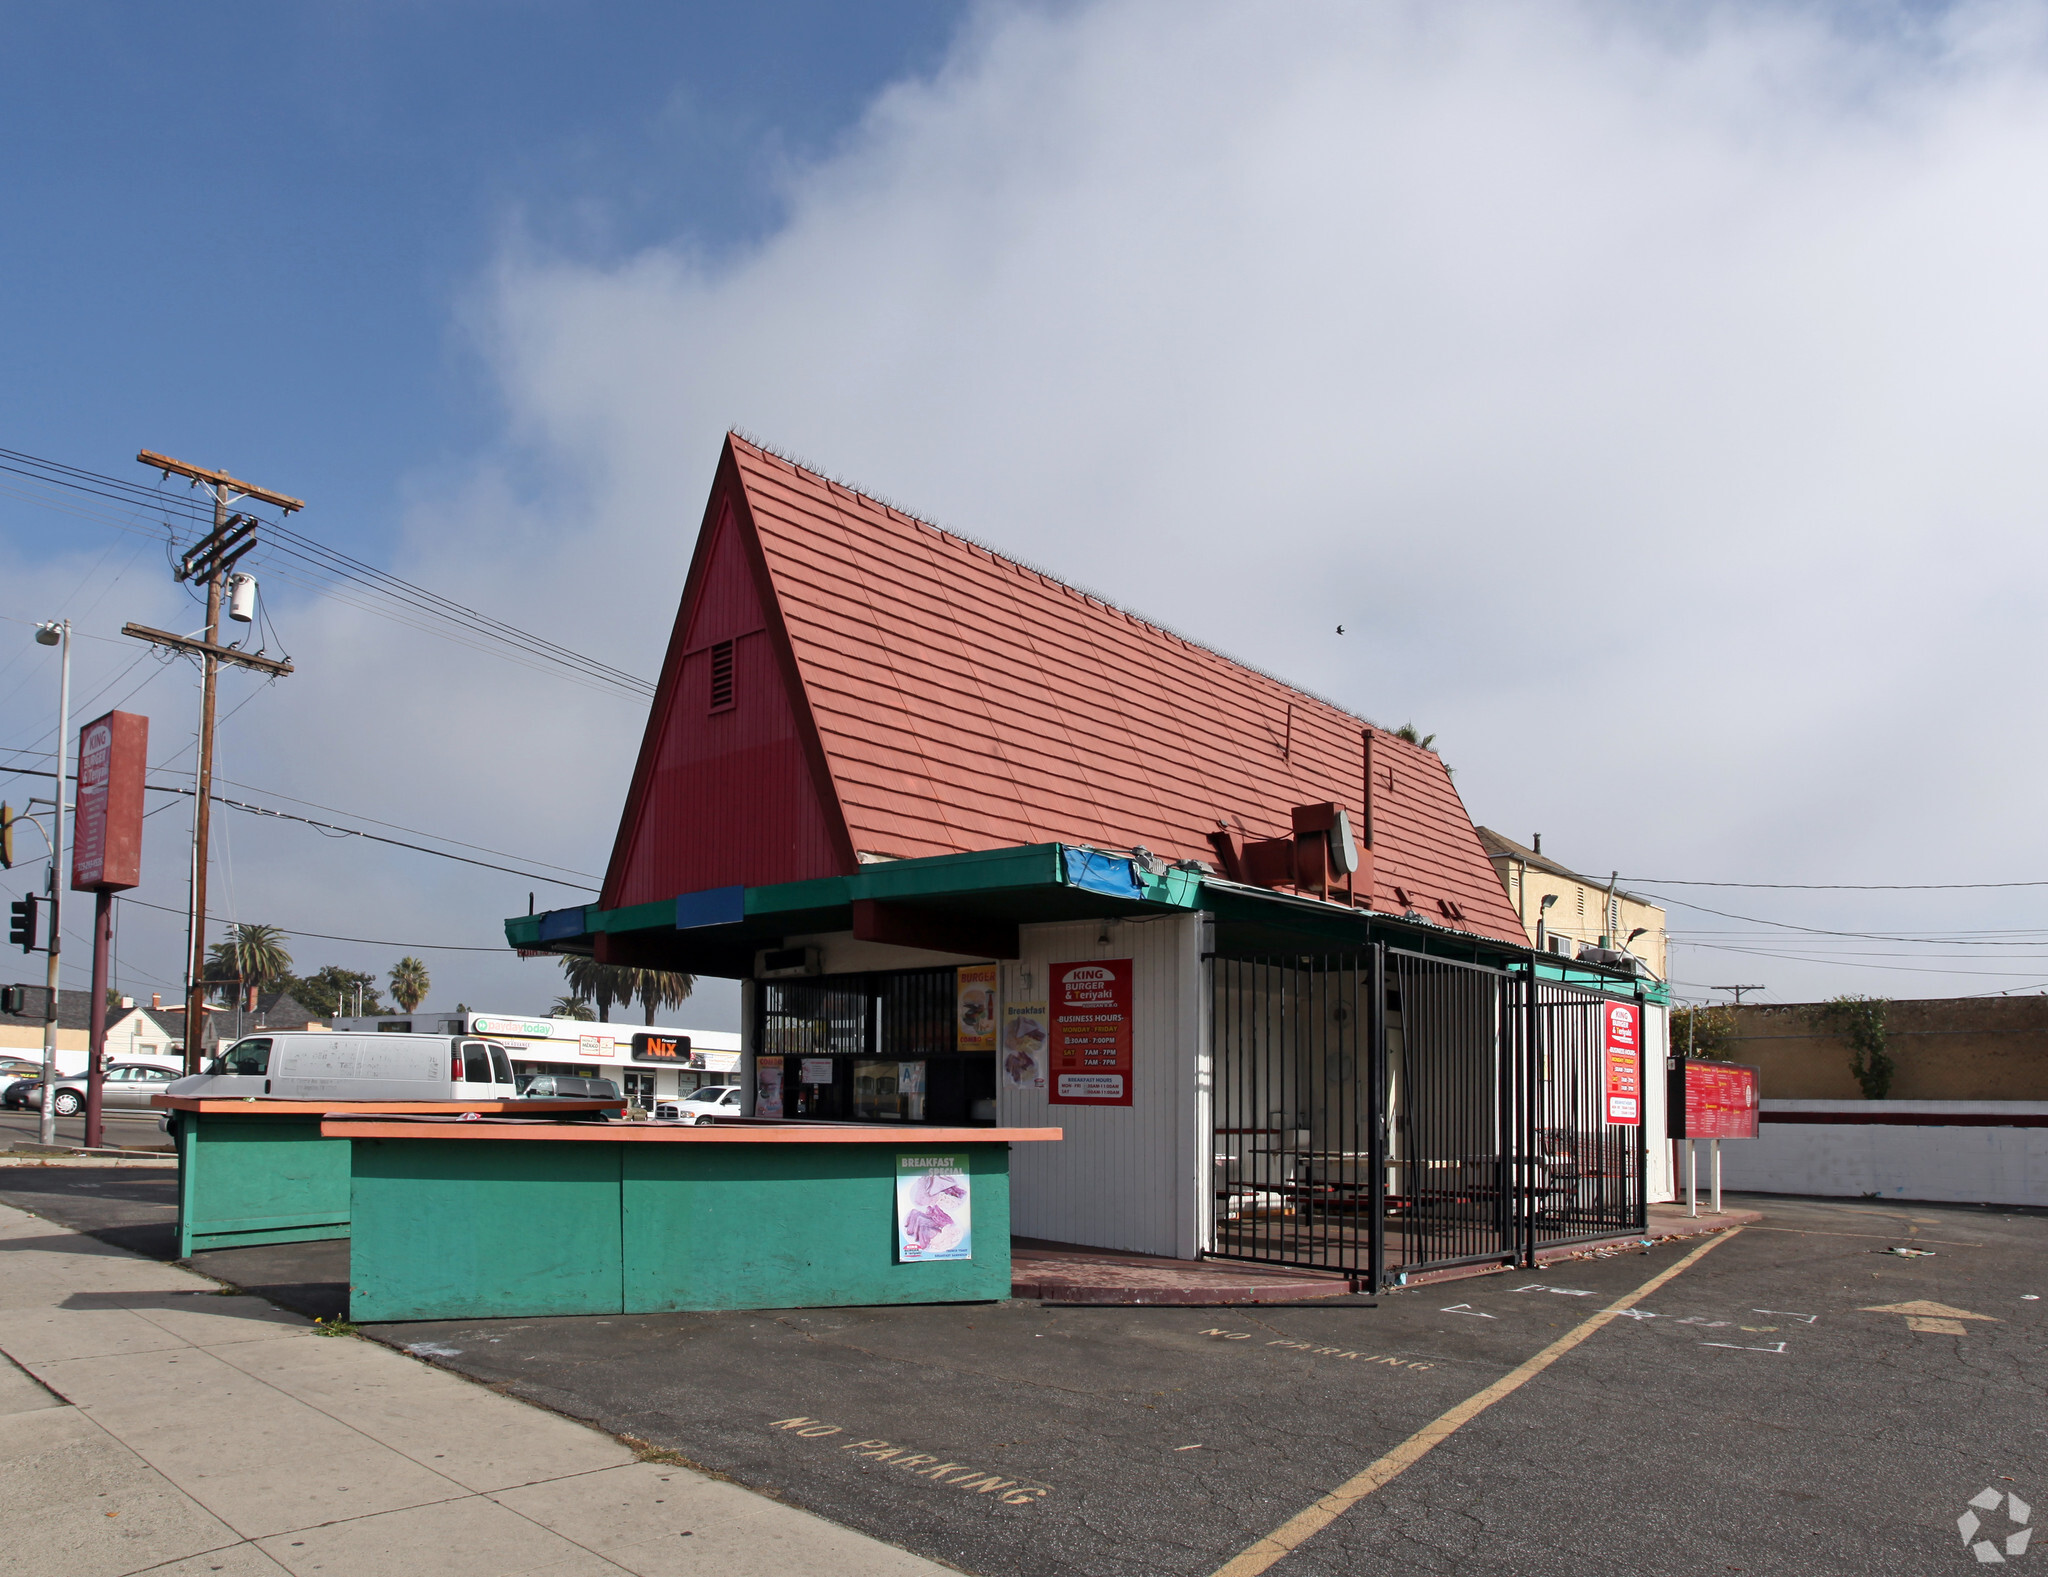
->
[995,915,1210,1260]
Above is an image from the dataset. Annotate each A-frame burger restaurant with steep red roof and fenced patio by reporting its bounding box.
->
[506,436,1669,1284]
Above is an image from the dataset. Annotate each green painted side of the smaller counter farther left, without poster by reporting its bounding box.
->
[172,1112,348,1258]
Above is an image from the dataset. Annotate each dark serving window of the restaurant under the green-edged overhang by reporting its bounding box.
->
[754,969,995,1126]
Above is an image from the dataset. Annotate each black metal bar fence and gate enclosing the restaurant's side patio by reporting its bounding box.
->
[1208,946,1645,1286]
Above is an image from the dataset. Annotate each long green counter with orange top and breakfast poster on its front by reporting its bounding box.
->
[319,1114,1061,1321]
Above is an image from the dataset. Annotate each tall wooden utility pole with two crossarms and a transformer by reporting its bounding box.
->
[121,449,305,1073]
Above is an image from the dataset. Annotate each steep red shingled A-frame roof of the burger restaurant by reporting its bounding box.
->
[604,434,1524,944]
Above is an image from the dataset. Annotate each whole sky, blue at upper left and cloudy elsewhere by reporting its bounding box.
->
[0,0,2048,1028]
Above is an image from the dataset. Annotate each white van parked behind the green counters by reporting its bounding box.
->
[164,1030,518,1100]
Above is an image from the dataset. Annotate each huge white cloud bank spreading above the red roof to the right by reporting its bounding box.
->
[475,0,2048,995]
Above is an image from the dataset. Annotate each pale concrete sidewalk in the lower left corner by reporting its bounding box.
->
[0,1206,944,1577]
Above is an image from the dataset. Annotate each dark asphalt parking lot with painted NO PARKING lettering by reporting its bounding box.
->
[0,1167,2048,1577]
